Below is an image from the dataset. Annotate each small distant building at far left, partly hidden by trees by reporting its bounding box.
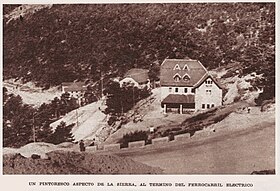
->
[61,82,87,102]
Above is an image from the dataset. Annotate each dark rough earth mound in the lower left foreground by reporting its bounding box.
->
[3,151,161,174]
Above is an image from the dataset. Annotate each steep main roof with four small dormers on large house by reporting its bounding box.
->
[160,59,207,86]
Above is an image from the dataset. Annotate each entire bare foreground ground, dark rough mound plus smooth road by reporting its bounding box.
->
[3,122,275,174]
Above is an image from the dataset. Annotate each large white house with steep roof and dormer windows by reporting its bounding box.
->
[160,59,222,114]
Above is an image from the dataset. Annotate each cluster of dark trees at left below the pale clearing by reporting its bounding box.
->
[3,88,78,147]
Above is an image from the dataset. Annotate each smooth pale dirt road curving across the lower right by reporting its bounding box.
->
[117,122,275,174]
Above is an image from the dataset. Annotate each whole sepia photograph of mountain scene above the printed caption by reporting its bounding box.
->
[2,2,276,175]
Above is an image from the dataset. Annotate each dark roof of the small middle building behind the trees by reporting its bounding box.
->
[124,68,149,84]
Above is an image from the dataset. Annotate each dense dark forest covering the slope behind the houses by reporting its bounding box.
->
[3,3,275,101]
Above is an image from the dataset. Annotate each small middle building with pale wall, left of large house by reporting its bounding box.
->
[120,68,150,88]
